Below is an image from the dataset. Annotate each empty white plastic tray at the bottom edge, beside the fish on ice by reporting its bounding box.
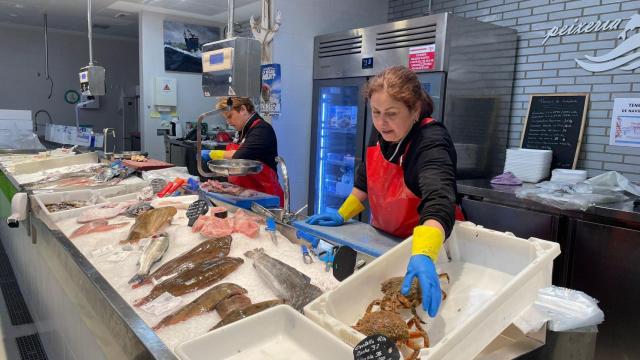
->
[175,305,353,360]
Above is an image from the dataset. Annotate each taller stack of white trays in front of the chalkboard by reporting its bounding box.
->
[504,149,553,183]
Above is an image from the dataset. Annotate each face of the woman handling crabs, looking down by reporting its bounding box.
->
[371,90,419,142]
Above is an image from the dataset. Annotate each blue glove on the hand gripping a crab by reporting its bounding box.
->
[400,255,442,317]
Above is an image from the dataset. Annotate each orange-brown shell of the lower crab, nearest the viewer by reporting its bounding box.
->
[354,310,409,341]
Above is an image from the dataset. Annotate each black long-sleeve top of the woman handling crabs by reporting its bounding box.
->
[354,121,457,237]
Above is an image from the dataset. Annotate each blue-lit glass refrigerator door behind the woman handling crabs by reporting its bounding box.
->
[309,78,365,214]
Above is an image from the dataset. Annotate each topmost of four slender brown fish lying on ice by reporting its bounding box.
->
[133,236,231,289]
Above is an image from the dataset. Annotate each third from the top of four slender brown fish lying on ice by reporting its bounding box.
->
[153,283,251,330]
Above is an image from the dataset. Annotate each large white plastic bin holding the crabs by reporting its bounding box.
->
[304,222,560,359]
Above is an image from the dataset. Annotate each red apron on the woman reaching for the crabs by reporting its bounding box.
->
[366,118,464,239]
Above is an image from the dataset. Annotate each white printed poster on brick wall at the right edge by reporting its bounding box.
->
[609,99,640,147]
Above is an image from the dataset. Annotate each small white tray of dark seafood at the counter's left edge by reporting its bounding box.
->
[31,190,106,229]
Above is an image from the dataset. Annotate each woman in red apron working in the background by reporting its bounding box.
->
[201,97,284,206]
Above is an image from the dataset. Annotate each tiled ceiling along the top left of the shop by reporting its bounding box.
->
[0,0,260,38]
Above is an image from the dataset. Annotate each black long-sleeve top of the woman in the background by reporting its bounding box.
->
[233,113,278,172]
